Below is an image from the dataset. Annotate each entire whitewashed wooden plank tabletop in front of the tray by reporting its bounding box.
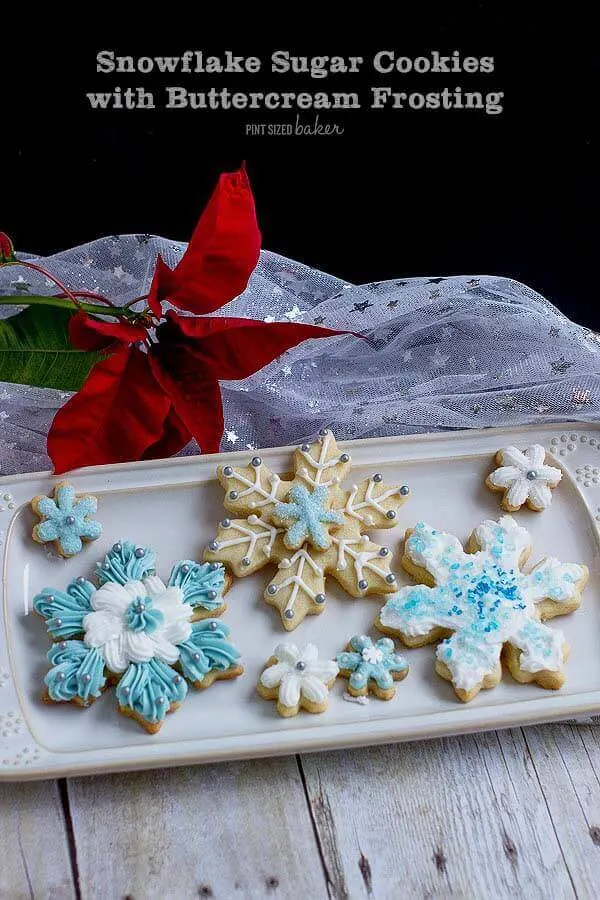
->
[0,720,600,900]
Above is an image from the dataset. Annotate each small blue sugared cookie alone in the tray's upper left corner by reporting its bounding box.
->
[31,481,102,557]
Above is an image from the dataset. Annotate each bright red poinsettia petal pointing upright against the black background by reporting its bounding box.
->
[149,166,261,318]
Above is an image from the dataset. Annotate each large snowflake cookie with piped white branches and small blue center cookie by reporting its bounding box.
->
[204,429,409,631]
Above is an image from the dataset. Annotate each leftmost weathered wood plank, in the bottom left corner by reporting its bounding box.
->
[0,781,75,900]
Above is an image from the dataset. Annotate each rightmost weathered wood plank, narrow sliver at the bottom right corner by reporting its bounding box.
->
[525,724,600,897]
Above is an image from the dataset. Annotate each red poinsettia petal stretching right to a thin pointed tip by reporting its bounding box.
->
[157,311,348,381]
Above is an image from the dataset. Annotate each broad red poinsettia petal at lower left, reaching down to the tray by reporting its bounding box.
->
[48,347,171,474]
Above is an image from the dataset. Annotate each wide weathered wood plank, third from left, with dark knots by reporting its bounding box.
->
[302,730,575,900]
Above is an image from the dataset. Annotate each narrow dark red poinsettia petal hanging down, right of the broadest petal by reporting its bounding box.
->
[149,344,225,453]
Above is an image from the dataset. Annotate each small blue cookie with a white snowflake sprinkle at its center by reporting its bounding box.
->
[337,634,408,700]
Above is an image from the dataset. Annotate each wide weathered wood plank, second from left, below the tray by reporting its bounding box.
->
[69,757,327,900]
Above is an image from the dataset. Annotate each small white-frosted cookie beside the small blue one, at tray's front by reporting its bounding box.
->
[257,644,338,718]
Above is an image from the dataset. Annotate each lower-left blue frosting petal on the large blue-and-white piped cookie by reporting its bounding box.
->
[44,641,106,705]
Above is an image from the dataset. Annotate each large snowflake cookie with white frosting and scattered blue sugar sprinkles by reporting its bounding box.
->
[376,516,588,701]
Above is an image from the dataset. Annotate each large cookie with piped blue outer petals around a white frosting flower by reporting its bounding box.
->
[33,541,243,734]
